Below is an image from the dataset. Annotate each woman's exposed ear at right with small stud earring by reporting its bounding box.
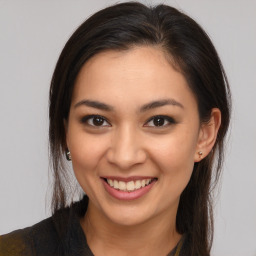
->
[194,108,221,162]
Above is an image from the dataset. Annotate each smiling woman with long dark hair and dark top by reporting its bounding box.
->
[0,2,230,256]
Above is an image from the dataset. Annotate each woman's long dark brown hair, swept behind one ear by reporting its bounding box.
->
[49,2,230,256]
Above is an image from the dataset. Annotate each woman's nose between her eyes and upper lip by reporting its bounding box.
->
[107,126,147,170]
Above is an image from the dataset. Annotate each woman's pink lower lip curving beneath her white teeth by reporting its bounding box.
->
[102,179,156,200]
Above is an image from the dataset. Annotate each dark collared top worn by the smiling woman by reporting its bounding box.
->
[0,196,188,256]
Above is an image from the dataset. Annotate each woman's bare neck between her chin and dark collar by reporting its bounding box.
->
[81,202,181,256]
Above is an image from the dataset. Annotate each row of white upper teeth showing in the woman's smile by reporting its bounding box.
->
[107,179,153,192]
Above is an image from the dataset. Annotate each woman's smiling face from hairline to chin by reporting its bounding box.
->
[66,47,204,225]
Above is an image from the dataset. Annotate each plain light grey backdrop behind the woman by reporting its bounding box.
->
[0,0,256,256]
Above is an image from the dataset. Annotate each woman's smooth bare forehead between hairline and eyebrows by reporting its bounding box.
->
[72,46,195,111]
